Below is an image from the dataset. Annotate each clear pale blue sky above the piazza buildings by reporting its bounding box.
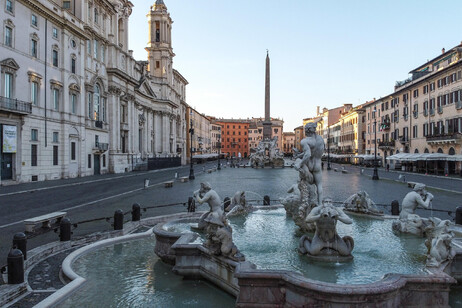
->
[130,0,462,131]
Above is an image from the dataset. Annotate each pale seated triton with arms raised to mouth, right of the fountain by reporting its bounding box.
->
[392,183,435,236]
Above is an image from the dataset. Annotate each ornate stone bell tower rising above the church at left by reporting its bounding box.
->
[145,0,175,80]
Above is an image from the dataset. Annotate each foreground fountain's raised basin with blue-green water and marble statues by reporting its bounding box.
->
[30,124,462,307]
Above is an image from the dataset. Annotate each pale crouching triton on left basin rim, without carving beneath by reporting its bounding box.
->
[194,182,226,229]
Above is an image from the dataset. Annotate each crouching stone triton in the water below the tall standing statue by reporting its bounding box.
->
[299,198,354,258]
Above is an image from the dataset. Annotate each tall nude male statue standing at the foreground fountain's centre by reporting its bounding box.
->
[295,123,324,205]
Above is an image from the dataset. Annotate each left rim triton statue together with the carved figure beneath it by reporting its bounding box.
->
[194,182,245,261]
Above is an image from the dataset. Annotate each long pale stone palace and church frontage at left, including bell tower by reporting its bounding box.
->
[0,0,188,184]
